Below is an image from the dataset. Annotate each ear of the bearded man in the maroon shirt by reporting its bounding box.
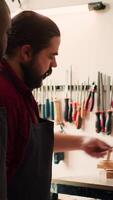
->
[20,44,32,62]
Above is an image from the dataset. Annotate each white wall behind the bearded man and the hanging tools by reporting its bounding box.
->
[6,0,113,176]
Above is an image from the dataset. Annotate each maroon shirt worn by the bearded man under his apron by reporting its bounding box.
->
[0,60,38,181]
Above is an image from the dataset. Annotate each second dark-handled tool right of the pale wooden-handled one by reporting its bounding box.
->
[68,66,73,122]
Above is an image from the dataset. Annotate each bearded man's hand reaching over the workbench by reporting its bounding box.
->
[82,138,112,158]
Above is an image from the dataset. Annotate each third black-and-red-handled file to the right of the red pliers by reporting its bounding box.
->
[105,76,112,135]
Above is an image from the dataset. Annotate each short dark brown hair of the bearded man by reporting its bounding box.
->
[6,11,60,56]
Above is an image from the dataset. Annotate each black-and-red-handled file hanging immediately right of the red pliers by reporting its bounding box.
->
[95,72,101,133]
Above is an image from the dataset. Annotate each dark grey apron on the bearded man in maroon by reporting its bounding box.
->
[7,119,54,200]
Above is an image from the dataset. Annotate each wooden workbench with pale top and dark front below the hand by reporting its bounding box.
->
[51,176,113,200]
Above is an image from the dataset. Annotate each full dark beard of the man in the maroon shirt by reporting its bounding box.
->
[20,63,52,90]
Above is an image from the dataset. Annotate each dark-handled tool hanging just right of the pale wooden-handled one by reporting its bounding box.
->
[64,70,69,122]
